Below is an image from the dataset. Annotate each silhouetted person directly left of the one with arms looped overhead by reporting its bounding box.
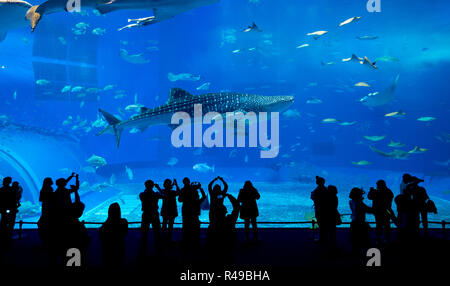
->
[178,177,206,245]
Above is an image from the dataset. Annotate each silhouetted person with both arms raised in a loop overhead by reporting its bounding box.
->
[208,177,228,227]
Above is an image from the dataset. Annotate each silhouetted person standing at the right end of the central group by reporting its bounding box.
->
[237,181,261,240]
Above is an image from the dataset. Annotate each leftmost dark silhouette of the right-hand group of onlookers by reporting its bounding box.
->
[311,176,338,243]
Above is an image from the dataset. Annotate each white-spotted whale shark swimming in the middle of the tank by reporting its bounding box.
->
[97,88,294,147]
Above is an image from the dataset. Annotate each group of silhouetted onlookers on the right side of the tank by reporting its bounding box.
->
[311,174,437,253]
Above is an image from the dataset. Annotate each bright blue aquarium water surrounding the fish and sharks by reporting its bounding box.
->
[0,0,450,226]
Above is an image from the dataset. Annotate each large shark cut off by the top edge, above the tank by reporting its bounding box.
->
[26,0,220,31]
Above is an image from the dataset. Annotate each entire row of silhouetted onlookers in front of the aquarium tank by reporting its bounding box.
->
[0,173,437,266]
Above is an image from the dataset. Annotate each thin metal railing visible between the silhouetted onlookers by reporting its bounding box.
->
[16,219,450,239]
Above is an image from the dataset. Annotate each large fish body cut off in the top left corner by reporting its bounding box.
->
[0,0,31,42]
